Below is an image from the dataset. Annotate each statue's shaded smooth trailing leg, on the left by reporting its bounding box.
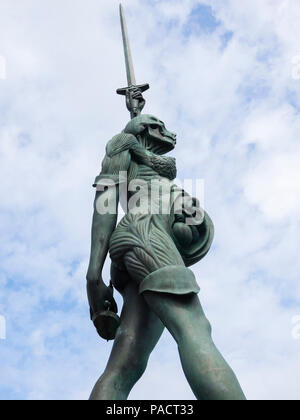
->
[90,282,164,400]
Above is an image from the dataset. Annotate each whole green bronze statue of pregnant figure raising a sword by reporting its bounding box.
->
[87,5,245,400]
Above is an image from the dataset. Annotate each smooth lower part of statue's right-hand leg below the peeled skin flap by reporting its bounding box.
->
[143,291,245,400]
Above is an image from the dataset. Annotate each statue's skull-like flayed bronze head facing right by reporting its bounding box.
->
[124,114,176,155]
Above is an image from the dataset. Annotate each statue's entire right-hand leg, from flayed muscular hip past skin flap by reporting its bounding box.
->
[110,214,245,400]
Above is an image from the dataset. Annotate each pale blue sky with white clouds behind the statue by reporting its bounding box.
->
[0,0,300,400]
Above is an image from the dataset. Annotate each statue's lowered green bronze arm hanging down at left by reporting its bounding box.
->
[87,133,137,318]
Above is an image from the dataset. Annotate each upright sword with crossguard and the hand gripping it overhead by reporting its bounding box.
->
[117,4,150,118]
